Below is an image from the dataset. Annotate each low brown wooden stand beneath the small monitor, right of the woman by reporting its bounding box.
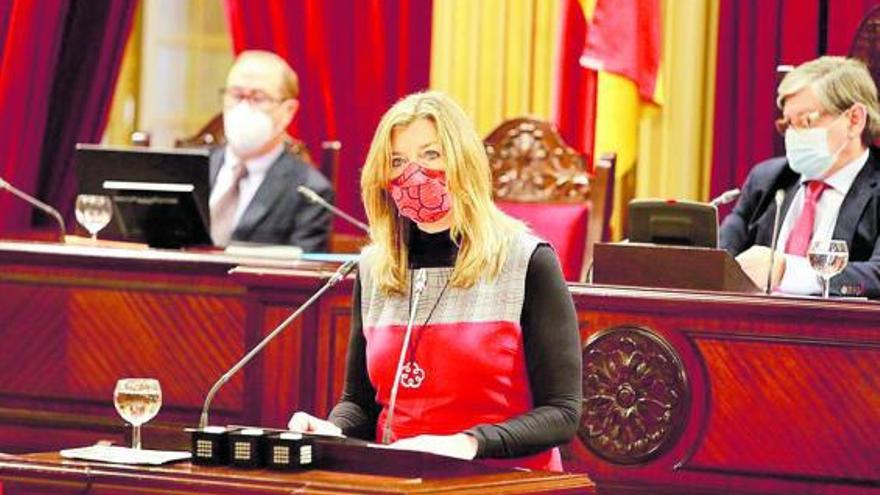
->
[593,243,761,294]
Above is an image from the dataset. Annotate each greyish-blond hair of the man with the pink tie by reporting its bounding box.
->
[776,56,880,146]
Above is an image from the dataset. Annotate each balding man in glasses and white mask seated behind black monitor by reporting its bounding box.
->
[210,50,333,251]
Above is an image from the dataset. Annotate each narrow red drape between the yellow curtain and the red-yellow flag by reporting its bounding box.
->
[553,0,596,162]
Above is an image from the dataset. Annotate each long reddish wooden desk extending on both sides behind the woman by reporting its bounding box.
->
[0,243,880,494]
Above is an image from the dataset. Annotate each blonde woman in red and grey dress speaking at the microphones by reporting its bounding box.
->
[289,92,582,470]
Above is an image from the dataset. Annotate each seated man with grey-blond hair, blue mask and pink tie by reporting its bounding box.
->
[720,57,880,297]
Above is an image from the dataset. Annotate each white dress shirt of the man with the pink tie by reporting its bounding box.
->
[776,150,869,294]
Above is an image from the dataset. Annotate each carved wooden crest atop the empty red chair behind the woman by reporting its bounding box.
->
[486,118,590,202]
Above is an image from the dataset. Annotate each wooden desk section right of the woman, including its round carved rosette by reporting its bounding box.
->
[566,284,880,494]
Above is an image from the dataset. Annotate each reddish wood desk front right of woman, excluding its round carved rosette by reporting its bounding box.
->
[567,286,880,494]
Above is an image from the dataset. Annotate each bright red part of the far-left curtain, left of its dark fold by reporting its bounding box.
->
[0,0,70,232]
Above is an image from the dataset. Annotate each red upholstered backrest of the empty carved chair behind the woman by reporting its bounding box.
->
[495,201,591,280]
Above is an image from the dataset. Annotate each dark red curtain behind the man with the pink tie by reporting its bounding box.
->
[711,0,880,202]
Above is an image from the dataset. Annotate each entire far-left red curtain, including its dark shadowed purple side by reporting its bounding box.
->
[0,0,136,231]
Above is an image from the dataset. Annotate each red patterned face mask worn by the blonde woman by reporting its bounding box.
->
[388,162,452,223]
